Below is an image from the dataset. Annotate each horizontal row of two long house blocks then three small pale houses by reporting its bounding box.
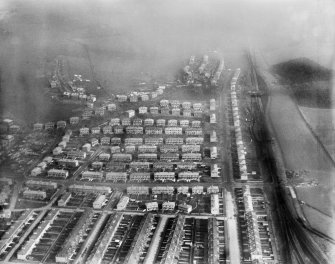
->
[127,185,220,195]
